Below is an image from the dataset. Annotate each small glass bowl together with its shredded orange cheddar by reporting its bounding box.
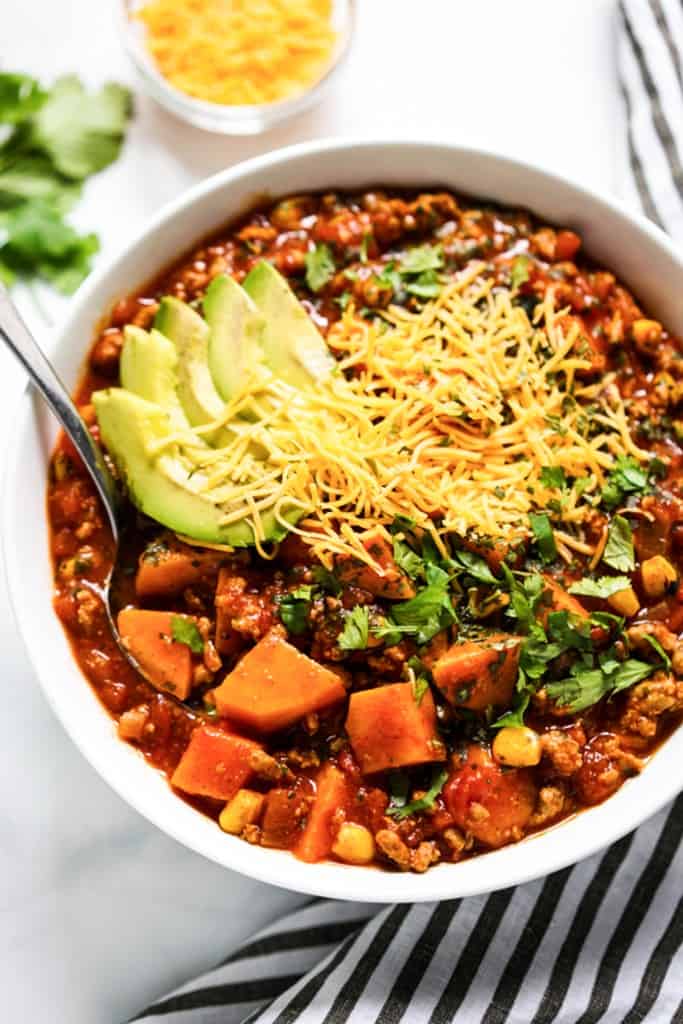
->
[120,0,355,135]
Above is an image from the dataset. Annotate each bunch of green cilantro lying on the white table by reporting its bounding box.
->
[0,73,131,293]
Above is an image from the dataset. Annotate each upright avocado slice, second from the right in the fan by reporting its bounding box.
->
[204,273,265,411]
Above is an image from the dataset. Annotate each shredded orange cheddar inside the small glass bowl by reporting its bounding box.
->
[135,0,336,105]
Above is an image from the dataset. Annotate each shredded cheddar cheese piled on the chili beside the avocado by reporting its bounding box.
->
[148,264,646,566]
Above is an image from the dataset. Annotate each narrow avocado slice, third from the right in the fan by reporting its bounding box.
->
[155,295,233,447]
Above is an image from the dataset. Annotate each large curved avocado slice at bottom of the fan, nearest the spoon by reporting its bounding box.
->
[92,388,302,548]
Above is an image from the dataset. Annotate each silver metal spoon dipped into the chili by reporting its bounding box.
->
[0,285,146,678]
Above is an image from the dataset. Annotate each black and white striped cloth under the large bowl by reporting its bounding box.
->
[135,0,683,1024]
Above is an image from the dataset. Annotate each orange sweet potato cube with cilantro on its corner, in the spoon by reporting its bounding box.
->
[117,608,193,700]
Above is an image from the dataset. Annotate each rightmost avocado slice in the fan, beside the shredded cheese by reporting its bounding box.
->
[243,260,335,390]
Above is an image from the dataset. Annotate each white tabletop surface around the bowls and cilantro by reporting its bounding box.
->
[0,0,624,1024]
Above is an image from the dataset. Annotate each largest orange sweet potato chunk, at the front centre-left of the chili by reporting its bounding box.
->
[214,631,346,732]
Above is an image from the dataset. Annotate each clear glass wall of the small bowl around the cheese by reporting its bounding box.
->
[119,0,355,135]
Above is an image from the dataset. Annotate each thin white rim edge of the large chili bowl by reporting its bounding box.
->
[5,138,683,903]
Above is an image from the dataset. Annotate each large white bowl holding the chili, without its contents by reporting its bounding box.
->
[2,141,683,902]
